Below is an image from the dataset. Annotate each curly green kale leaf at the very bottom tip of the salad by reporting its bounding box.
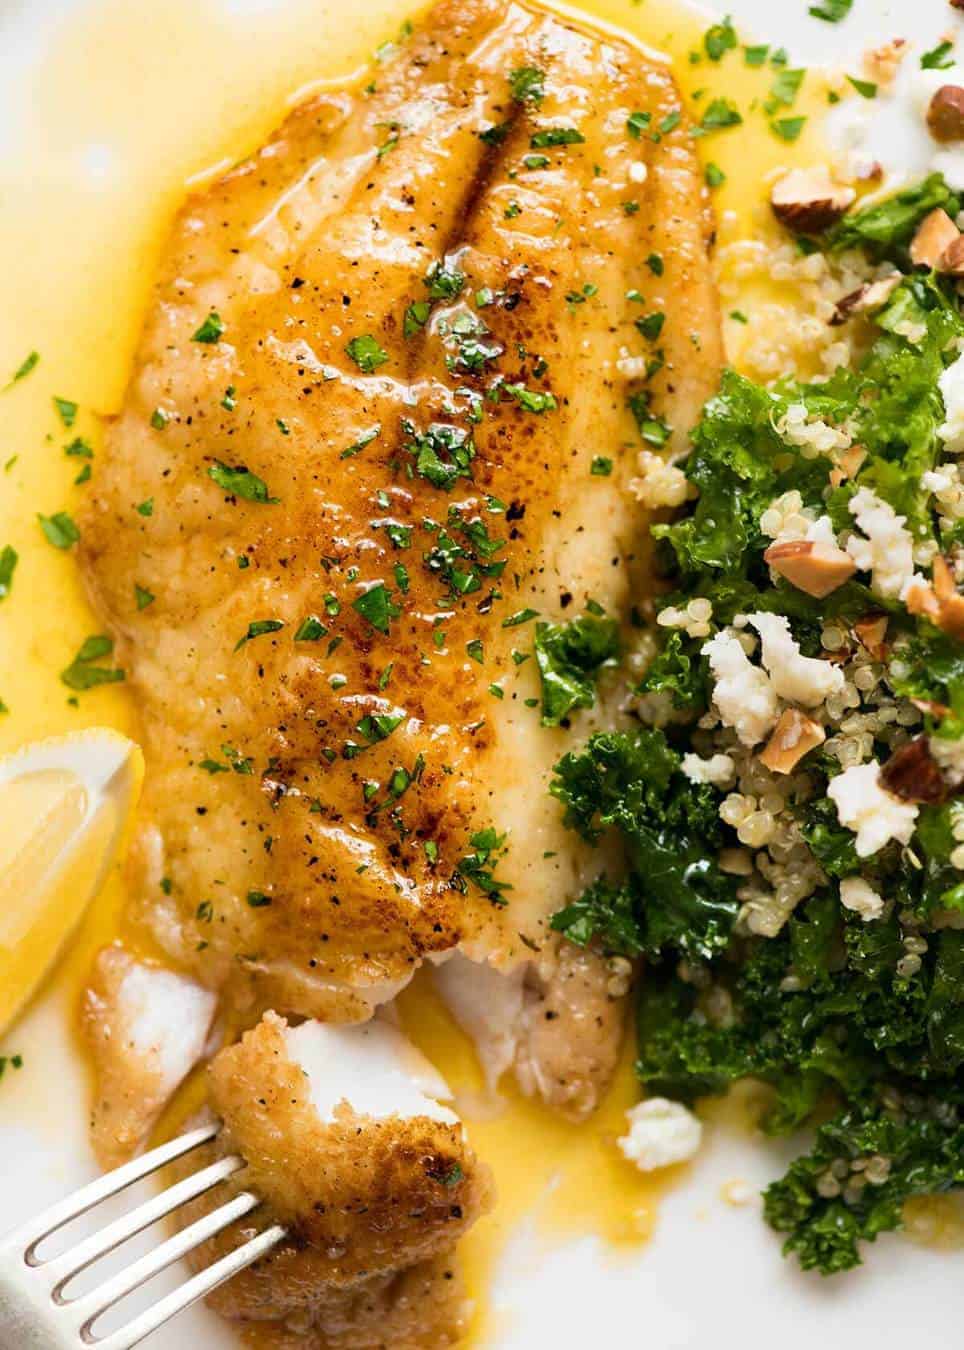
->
[764,1107,964,1274]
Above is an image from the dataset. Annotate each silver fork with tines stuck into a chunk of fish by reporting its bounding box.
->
[0,1123,285,1350]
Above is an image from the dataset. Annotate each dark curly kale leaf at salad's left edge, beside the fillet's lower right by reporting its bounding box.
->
[550,730,739,957]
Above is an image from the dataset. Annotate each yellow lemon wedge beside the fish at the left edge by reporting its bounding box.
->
[0,728,144,1031]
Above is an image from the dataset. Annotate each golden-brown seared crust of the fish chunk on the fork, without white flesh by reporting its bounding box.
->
[174,1013,493,1328]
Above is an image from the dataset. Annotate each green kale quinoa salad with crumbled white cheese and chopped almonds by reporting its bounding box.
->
[550,176,964,1274]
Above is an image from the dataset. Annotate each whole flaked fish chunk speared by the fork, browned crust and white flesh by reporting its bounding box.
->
[174,1013,493,1347]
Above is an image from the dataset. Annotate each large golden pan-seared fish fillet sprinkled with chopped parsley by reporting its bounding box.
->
[80,0,721,1021]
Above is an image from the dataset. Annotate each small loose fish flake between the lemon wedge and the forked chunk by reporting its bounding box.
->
[82,945,217,1168]
